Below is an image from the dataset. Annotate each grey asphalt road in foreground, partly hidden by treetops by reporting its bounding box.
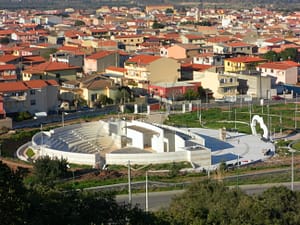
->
[116,182,300,211]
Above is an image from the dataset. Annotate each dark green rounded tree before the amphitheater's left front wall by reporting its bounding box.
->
[33,156,68,187]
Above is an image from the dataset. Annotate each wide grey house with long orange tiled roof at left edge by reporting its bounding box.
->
[0,80,59,114]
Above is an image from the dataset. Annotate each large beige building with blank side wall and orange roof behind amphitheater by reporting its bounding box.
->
[124,55,180,88]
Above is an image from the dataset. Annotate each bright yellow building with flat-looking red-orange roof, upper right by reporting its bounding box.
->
[224,56,267,72]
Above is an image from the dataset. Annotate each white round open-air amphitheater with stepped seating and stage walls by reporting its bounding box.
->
[28,119,211,167]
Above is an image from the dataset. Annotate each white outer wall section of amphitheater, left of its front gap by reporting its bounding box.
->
[39,147,100,166]
